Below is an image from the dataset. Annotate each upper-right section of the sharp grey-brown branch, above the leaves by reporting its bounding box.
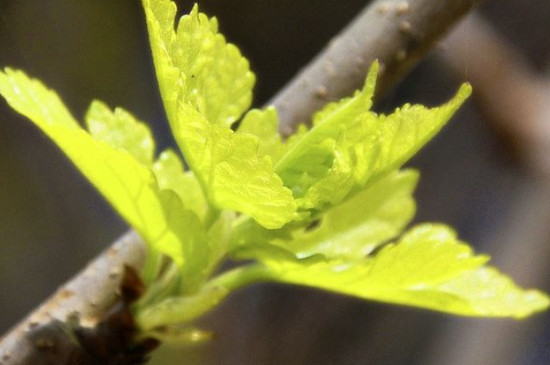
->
[276,0,488,135]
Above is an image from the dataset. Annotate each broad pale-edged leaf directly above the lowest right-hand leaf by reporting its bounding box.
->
[284,170,418,259]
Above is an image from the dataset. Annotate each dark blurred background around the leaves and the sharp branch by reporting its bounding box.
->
[0,0,550,365]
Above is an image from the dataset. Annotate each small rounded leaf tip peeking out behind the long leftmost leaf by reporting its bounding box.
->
[85,100,155,165]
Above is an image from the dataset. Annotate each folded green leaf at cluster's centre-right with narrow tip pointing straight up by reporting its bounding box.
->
[275,64,378,210]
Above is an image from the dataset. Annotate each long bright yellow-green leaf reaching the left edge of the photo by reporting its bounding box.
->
[0,68,193,265]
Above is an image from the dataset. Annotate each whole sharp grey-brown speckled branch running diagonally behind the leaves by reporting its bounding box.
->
[0,0,480,365]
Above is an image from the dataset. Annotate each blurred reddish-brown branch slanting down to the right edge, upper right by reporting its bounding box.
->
[443,12,550,175]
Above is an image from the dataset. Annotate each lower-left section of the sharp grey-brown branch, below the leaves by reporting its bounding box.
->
[0,231,145,365]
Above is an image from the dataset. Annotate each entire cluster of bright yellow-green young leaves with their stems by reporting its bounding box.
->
[0,0,548,341]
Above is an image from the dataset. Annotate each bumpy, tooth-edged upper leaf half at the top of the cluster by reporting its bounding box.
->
[176,5,255,126]
